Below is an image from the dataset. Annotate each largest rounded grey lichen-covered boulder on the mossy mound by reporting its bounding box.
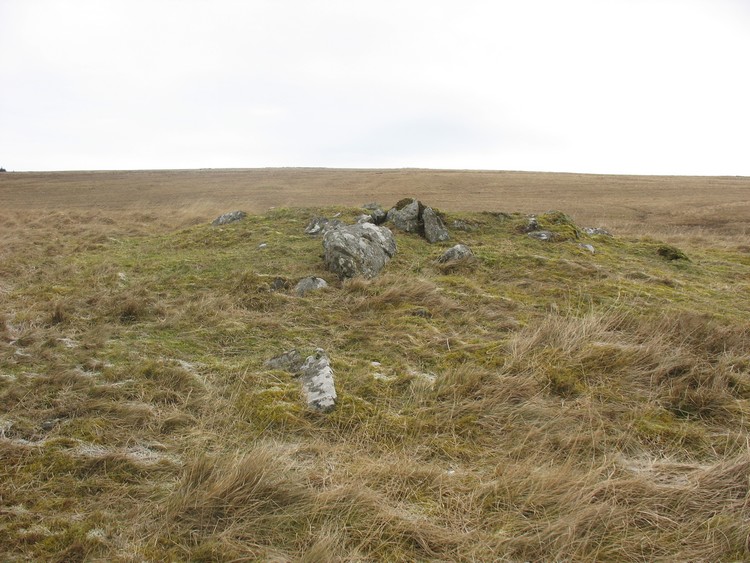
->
[323,223,396,278]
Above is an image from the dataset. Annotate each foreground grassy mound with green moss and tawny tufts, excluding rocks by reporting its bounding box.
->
[0,205,750,561]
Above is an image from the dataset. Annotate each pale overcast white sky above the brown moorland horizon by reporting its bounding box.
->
[0,0,750,176]
